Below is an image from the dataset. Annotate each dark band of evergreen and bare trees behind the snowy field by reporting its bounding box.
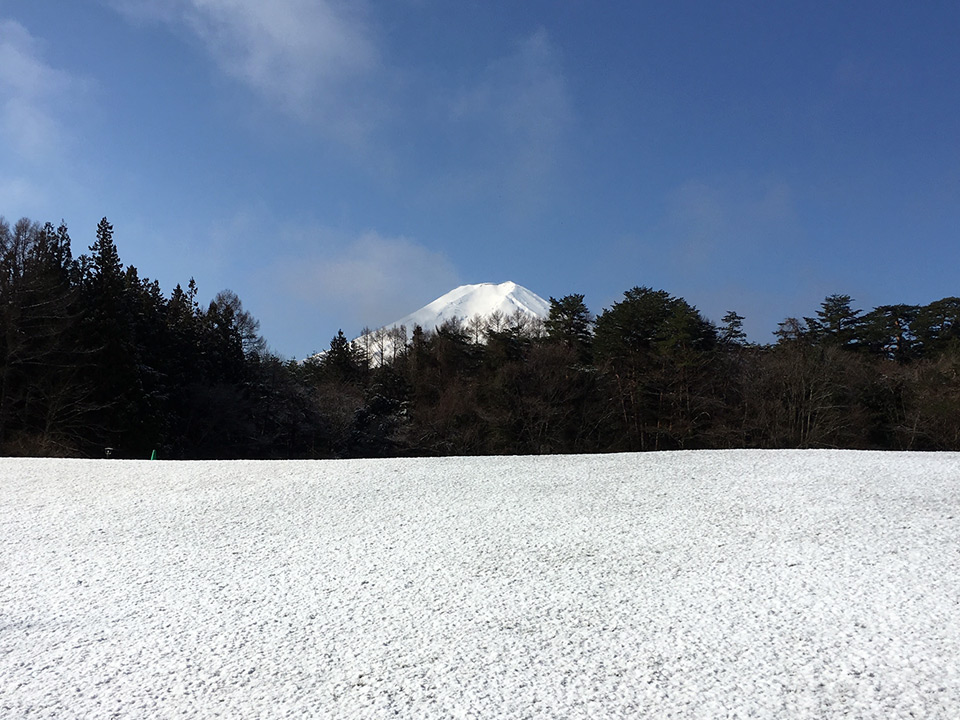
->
[0,218,960,459]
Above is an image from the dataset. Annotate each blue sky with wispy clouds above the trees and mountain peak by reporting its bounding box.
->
[0,0,960,357]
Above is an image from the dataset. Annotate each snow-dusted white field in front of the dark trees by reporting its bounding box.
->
[0,451,960,719]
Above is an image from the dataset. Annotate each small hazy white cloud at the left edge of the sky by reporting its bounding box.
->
[0,20,80,161]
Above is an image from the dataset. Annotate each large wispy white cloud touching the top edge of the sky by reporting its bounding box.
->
[109,0,379,135]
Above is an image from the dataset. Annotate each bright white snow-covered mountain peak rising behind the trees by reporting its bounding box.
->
[385,282,550,332]
